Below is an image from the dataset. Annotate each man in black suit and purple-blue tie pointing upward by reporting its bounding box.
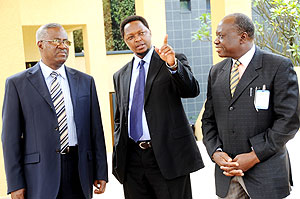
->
[113,16,204,199]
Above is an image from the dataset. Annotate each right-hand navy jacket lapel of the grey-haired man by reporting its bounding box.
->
[65,67,79,110]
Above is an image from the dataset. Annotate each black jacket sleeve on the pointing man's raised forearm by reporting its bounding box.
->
[172,54,200,98]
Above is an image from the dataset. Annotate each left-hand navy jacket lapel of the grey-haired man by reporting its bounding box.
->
[26,63,55,110]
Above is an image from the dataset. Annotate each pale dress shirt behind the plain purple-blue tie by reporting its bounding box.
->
[128,46,154,140]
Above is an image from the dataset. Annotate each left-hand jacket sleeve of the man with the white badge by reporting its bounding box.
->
[202,68,222,158]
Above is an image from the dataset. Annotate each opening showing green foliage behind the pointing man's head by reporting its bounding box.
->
[103,0,135,51]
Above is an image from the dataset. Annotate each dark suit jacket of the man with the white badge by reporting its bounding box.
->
[202,48,299,199]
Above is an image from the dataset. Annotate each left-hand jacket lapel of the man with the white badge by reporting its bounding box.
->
[218,59,231,101]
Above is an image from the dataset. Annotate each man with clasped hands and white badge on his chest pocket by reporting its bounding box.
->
[202,13,299,199]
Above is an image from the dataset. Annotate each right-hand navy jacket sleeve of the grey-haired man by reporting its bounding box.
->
[91,78,108,182]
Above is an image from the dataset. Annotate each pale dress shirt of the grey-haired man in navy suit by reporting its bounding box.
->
[39,60,78,146]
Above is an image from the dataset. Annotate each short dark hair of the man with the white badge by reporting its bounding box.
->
[232,13,255,39]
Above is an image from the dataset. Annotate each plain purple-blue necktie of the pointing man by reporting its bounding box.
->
[130,60,145,142]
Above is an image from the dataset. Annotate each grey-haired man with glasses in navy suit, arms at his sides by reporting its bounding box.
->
[2,23,107,199]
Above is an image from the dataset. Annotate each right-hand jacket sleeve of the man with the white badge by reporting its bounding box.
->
[250,59,299,161]
